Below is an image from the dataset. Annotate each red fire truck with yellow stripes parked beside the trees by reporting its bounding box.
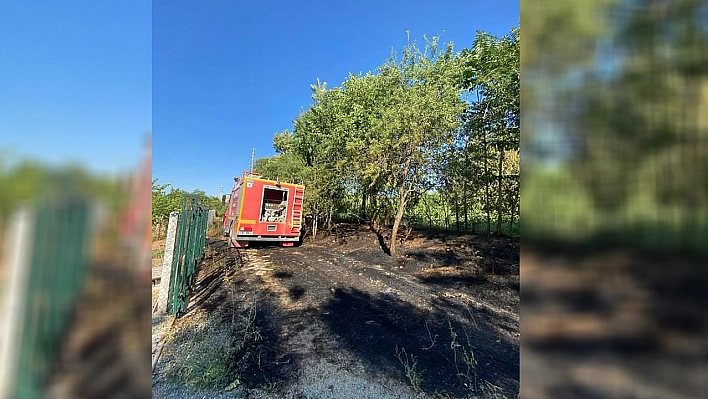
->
[223,172,305,248]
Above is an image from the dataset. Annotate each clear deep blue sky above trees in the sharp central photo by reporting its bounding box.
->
[152,0,519,195]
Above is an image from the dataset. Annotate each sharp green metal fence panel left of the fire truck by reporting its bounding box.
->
[168,195,209,316]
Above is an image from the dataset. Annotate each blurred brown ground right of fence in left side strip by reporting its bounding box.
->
[46,264,150,399]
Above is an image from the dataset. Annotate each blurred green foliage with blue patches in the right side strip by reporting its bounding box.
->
[521,0,708,254]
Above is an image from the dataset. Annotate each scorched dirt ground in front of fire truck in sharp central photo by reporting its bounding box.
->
[153,224,520,399]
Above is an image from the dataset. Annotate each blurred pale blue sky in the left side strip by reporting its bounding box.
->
[0,0,152,173]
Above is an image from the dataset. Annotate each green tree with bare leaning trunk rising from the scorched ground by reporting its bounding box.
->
[382,38,464,255]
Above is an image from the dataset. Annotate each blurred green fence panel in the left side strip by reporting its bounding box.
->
[12,191,92,399]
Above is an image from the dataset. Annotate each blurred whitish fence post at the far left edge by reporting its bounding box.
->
[0,209,34,399]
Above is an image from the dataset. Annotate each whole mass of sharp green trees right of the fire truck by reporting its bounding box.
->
[255,28,519,254]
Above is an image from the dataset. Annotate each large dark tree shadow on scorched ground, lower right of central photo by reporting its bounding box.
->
[321,288,519,397]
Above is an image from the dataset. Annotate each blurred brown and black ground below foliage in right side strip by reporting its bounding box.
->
[521,247,708,399]
